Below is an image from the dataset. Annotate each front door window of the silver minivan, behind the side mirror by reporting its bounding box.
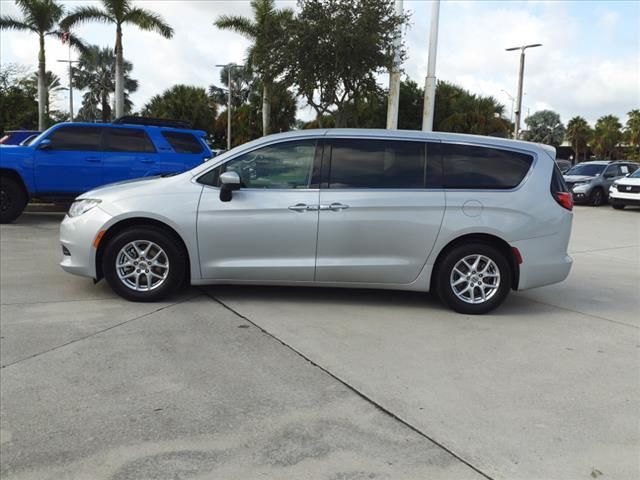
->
[199,140,316,189]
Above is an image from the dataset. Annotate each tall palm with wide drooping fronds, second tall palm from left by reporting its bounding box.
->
[61,0,173,117]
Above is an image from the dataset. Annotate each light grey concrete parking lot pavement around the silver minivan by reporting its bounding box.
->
[0,206,640,480]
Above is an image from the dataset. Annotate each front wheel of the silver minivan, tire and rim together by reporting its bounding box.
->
[102,227,187,302]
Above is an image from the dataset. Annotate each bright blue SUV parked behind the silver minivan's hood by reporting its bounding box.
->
[0,117,213,223]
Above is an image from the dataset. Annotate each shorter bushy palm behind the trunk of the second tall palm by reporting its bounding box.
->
[73,45,138,122]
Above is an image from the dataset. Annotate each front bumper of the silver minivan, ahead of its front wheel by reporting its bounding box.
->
[60,206,111,278]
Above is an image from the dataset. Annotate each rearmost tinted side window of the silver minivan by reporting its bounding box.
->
[440,143,533,189]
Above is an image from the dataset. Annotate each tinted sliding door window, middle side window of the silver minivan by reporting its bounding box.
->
[329,140,425,188]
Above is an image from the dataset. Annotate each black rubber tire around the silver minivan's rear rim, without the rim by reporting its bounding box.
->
[436,242,512,315]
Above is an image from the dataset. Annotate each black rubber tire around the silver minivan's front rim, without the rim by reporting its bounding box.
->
[102,227,187,302]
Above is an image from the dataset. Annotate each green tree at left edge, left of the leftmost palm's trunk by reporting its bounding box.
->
[0,64,38,134]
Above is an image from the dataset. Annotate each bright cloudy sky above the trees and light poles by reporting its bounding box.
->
[0,0,640,125]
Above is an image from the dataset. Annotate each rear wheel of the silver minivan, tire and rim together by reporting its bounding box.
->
[437,243,511,315]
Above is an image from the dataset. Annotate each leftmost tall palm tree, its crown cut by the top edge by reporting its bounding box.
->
[0,0,84,130]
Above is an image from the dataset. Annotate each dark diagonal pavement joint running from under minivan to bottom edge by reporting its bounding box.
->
[201,288,495,480]
